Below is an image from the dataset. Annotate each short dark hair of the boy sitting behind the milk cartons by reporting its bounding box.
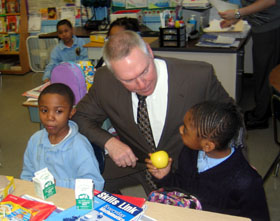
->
[38,83,75,107]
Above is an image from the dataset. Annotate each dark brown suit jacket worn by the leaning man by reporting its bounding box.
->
[73,58,232,177]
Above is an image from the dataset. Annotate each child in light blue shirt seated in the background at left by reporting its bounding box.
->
[42,19,88,82]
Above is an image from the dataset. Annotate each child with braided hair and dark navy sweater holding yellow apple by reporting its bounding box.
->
[146,101,269,221]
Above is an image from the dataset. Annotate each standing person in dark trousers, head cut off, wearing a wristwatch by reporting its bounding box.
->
[219,0,280,130]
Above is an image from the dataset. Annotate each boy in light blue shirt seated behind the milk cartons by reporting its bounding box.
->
[20,83,104,191]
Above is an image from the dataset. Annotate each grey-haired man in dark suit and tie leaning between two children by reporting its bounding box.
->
[74,31,231,193]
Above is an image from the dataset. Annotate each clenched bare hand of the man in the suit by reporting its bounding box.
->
[105,137,138,167]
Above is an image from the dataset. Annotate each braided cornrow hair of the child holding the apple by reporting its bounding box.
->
[190,101,244,150]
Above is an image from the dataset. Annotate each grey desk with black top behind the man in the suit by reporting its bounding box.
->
[84,37,247,101]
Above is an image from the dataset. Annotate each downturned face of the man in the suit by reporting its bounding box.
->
[111,47,157,96]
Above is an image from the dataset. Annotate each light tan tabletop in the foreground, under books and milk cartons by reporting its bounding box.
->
[13,179,250,221]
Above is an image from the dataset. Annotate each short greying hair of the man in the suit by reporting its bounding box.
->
[103,31,149,71]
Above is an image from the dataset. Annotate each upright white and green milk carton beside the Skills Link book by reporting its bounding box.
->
[75,179,94,209]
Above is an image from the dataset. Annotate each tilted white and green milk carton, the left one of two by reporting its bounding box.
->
[32,168,56,199]
